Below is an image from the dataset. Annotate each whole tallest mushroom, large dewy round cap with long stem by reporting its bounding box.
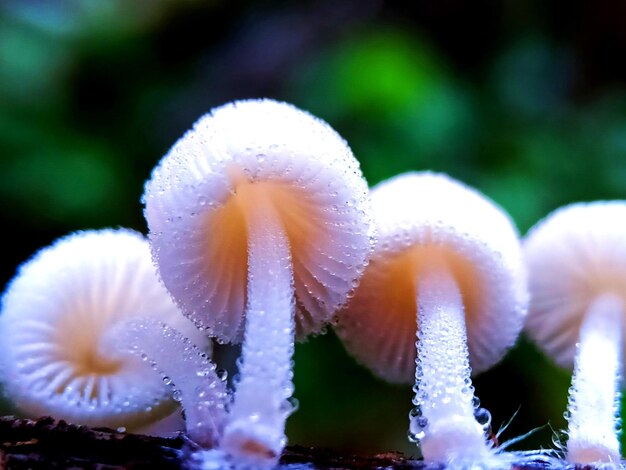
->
[144,99,371,466]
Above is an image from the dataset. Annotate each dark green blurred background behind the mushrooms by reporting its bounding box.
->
[0,0,626,454]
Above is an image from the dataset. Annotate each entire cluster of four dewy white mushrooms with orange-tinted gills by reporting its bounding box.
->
[0,100,626,468]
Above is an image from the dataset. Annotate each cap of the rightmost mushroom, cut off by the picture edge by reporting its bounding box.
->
[524,201,626,369]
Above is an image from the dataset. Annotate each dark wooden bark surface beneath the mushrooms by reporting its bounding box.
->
[0,416,596,470]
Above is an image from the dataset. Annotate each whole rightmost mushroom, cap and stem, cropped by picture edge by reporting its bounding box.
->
[524,201,626,464]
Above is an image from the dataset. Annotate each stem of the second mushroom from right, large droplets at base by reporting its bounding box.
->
[410,268,489,463]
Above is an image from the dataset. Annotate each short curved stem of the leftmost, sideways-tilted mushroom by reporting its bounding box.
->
[112,318,228,449]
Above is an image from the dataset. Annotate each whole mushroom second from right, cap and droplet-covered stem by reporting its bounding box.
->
[337,172,527,466]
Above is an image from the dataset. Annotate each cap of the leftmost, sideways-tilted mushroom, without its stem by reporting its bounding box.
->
[0,229,207,430]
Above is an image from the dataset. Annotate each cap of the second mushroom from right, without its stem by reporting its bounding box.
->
[337,172,527,382]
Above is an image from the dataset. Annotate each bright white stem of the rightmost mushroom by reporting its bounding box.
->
[567,294,624,464]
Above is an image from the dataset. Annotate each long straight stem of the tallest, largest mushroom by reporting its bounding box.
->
[222,200,295,467]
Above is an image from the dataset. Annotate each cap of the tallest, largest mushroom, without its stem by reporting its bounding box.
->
[144,100,371,342]
